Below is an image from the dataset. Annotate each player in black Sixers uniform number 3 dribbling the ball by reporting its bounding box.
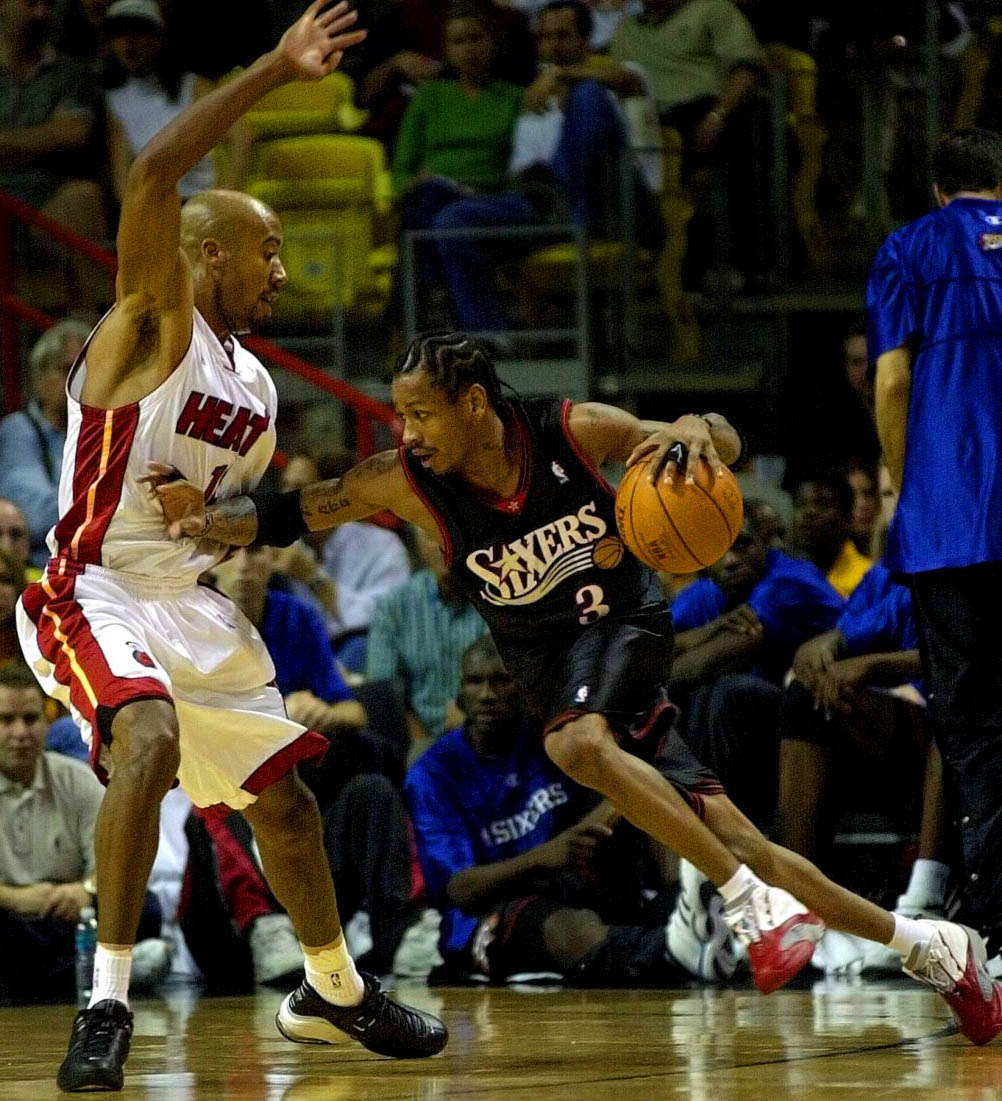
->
[151,333,1002,1043]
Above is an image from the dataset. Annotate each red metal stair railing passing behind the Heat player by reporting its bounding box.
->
[0,192,396,457]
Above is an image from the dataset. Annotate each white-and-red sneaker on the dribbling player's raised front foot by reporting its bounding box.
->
[723,883,825,994]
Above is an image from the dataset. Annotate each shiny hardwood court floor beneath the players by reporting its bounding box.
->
[0,982,1002,1101]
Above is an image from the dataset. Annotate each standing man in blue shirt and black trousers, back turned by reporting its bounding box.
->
[867,130,1002,949]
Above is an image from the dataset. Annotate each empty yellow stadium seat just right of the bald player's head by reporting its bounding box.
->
[247,134,393,321]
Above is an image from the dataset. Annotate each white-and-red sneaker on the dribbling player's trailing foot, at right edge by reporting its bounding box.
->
[904,920,1002,1044]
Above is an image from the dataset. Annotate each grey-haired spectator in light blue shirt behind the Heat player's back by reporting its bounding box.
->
[0,319,90,567]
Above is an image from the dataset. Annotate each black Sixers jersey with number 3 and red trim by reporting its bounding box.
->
[400,399,664,687]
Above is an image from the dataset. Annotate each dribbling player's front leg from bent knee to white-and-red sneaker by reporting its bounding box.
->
[545,713,825,993]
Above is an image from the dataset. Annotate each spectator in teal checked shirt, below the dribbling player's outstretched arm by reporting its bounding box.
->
[366,528,487,746]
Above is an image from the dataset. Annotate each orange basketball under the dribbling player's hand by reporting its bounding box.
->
[616,447,744,574]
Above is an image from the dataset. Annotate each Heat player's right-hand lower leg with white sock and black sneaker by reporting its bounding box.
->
[243,772,448,1058]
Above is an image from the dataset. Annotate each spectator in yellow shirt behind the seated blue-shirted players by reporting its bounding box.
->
[793,471,873,597]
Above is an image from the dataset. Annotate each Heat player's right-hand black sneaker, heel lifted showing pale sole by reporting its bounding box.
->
[275,971,449,1059]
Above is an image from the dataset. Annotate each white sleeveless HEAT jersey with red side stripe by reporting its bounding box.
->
[47,310,277,591]
